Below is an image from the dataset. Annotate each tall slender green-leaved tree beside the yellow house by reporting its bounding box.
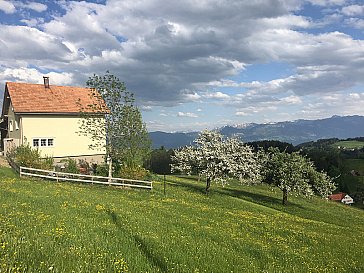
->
[79,71,151,180]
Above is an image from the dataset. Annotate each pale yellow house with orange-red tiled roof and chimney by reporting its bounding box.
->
[0,77,108,163]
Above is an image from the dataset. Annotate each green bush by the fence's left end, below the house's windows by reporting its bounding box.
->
[7,143,54,170]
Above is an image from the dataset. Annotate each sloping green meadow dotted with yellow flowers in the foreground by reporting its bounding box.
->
[0,168,364,272]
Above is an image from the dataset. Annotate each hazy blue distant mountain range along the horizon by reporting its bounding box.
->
[149,116,364,149]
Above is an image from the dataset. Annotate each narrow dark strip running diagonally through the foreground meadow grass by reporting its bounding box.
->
[106,209,168,272]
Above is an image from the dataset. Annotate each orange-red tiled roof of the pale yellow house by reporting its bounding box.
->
[5,82,108,113]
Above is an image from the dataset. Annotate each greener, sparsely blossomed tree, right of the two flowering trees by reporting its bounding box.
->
[263,148,336,205]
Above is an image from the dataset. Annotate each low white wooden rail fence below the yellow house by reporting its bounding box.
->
[19,167,153,190]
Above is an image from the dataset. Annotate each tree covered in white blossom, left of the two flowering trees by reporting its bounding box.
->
[172,130,260,192]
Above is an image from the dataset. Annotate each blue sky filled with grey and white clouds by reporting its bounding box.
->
[0,0,364,131]
